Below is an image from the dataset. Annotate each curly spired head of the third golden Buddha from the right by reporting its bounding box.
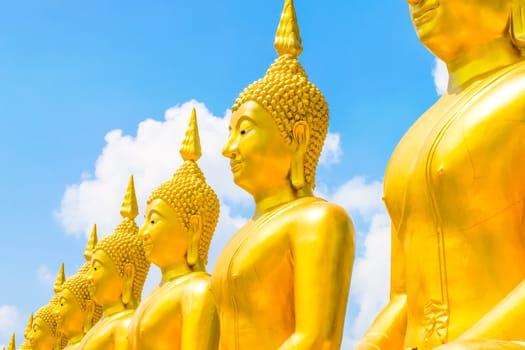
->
[140,109,219,271]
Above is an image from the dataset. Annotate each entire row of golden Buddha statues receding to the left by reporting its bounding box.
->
[9,0,525,350]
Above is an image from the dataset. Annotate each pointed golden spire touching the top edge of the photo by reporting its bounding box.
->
[273,0,303,58]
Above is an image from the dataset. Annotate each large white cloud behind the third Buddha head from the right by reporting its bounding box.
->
[55,100,250,237]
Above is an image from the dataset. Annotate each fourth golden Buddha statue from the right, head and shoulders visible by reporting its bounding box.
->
[80,177,149,350]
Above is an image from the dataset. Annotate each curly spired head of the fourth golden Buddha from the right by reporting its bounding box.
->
[87,177,149,309]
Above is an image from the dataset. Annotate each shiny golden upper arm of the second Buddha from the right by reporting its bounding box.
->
[292,203,355,338]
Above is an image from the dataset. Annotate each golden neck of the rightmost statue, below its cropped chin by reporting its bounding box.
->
[447,37,521,93]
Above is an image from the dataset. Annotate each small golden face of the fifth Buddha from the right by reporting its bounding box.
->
[55,289,84,336]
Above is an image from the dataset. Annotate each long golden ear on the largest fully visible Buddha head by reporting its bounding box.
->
[290,120,310,190]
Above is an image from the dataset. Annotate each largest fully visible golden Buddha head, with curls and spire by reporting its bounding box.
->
[223,0,328,197]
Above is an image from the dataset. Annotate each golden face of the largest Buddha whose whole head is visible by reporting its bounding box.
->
[222,101,293,195]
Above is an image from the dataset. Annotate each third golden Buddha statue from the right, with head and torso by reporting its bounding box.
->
[129,109,219,350]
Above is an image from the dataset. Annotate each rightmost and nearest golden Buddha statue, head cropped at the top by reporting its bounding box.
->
[357,0,525,350]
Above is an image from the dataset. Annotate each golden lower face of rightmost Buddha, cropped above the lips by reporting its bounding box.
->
[407,0,512,61]
